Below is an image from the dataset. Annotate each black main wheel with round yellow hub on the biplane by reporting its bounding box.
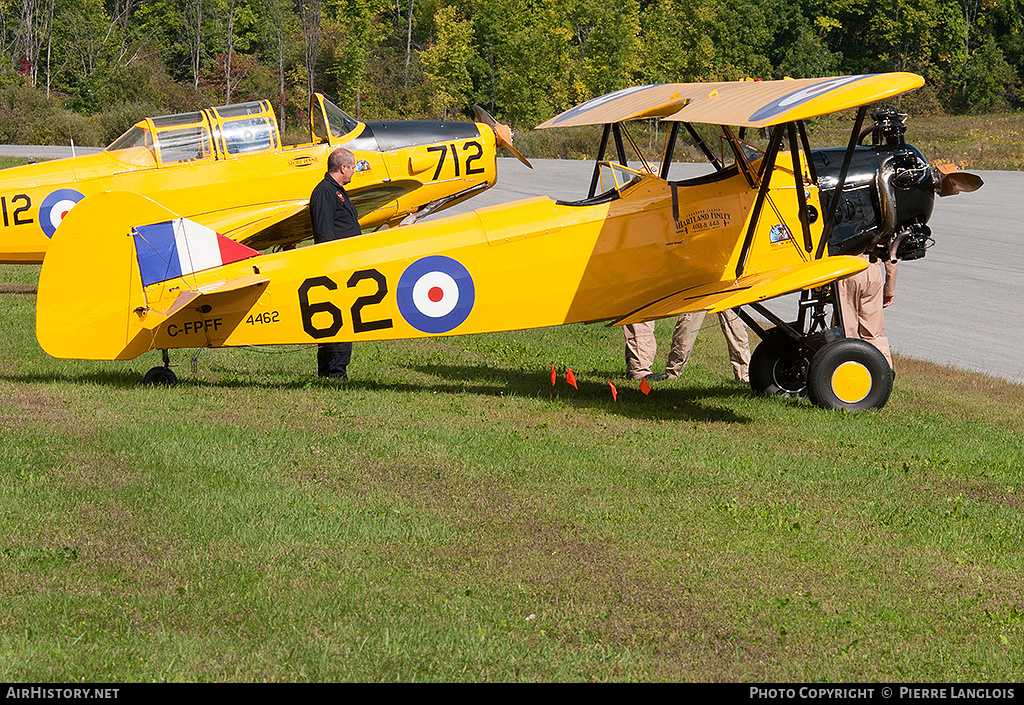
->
[807,338,893,411]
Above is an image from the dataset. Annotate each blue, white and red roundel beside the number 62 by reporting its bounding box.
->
[395,255,476,333]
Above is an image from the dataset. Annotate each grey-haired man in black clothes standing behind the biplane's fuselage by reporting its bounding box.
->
[309,148,360,379]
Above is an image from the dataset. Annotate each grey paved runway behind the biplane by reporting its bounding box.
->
[444,159,1024,383]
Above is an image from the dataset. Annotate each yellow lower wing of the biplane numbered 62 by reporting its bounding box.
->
[608,256,867,326]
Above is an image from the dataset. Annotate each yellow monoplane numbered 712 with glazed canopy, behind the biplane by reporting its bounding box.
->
[0,93,528,263]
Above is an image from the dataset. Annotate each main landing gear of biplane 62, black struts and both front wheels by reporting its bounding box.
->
[737,283,893,411]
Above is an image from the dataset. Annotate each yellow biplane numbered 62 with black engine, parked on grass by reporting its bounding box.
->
[37,73,980,410]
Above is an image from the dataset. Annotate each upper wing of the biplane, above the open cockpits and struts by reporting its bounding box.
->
[538,73,925,129]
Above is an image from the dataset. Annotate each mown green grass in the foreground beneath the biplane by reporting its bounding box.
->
[0,261,1024,681]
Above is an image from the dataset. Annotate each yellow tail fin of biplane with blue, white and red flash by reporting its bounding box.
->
[36,192,259,360]
